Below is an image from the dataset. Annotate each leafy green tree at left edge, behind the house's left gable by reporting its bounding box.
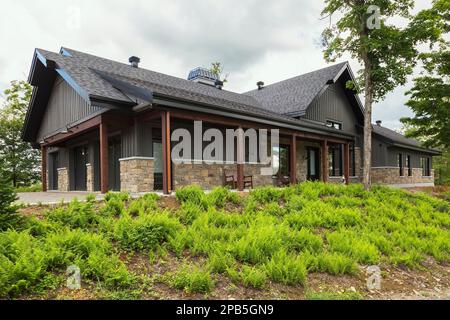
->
[0,81,40,187]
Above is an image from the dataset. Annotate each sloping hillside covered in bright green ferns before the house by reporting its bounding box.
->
[0,183,450,299]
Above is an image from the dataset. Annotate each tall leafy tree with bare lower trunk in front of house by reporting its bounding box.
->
[322,0,448,189]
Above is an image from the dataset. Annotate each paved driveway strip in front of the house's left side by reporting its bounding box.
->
[16,191,103,205]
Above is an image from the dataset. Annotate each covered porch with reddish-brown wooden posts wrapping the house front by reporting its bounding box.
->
[41,107,358,194]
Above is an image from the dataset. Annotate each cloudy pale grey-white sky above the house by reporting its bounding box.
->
[0,0,436,129]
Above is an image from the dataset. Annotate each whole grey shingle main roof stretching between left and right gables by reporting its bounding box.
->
[37,48,346,121]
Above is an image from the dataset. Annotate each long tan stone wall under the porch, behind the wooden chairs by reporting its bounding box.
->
[172,162,273,190]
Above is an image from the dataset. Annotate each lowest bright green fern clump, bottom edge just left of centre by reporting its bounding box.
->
[169,265,214,293]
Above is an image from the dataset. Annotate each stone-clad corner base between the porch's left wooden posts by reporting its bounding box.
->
[119,157,154,192]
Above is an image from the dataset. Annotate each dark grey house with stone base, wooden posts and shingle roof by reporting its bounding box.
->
[23,48,438,193]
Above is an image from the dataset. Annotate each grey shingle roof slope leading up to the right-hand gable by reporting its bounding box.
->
[244,62,347,114]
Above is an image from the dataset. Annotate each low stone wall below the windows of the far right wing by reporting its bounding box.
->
[371,167,434,185]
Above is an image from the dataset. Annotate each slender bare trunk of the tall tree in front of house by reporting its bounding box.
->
[363,53,373,190]
